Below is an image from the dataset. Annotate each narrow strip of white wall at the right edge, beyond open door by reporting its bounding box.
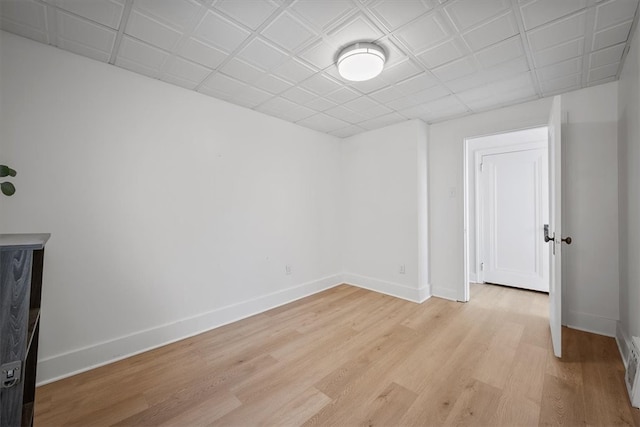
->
[618,24,640,352]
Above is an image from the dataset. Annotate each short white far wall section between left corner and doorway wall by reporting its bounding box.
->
[341,120,430,301]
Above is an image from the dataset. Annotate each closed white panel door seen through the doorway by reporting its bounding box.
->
[479,148,549,292]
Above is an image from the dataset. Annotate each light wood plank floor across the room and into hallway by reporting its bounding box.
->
[35,285,640,427]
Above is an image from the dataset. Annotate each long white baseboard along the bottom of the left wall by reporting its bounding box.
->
[37,275,343,385]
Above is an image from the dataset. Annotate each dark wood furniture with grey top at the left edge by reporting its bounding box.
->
[0,234,49,427]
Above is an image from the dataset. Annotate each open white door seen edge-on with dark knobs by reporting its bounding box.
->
[548,96,571,357]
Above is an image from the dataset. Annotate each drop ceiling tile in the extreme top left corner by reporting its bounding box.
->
[0,0,49,43]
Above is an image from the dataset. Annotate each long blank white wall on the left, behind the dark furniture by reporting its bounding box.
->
[0,32,342,381]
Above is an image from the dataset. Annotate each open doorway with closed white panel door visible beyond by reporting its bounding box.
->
[464,126,549,301]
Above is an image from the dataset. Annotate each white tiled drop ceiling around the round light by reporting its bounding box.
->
[0,0,638,137]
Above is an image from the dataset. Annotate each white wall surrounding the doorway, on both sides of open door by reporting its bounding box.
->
[429,82,619,335]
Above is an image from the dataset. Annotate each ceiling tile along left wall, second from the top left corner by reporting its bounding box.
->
[56,11,116,62]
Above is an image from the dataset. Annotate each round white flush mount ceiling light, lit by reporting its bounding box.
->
[338,42,386,82]
